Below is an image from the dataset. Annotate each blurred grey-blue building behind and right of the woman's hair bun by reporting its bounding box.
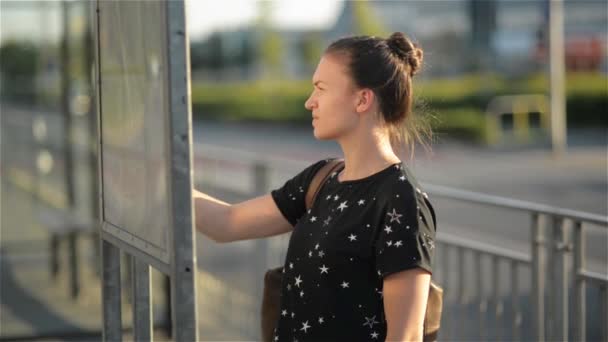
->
[327,0,608,76]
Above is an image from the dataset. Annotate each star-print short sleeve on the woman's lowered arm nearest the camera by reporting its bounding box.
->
[374,180,436,278]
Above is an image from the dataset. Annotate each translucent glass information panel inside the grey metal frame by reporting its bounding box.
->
[99,1,171,264]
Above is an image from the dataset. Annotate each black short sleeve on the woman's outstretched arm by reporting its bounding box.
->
[270,159,329,226]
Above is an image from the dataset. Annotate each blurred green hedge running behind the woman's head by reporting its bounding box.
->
[192,74,608,141]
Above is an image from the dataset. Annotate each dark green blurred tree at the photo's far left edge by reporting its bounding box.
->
[0,41,39,101]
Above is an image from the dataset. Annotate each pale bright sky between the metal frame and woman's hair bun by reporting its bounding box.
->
[186,0,343,39]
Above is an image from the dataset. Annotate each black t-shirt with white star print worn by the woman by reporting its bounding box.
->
[271,159,435,342]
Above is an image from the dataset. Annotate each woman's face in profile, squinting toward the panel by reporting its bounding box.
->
[304,54,359,140]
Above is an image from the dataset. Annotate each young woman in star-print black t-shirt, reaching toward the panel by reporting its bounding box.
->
[195,32,435,342]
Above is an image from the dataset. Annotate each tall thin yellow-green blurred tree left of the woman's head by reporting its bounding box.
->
[256,0,284,78]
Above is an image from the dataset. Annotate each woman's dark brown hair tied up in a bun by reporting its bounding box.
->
[325,32,432,157]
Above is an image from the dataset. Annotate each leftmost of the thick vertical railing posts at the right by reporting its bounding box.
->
[531,212,546,341]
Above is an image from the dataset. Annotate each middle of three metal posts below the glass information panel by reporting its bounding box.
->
[131,257,153,341]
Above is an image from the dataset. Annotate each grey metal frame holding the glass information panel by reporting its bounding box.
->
[91,0,198,341]
